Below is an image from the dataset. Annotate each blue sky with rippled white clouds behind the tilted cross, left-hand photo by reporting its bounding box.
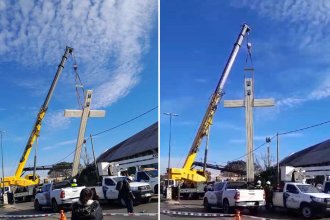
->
[0,0,158,179]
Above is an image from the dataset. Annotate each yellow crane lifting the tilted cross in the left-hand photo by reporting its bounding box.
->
[0,47,73,187]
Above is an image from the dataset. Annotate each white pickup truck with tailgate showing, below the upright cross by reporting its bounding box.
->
[203,182,265,213]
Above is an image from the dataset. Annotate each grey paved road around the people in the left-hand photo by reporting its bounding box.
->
[0,198,158,220]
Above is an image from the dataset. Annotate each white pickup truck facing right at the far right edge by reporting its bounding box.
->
[272,182,330,218]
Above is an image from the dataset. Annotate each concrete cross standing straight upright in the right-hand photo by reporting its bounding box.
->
[224,78,275,182]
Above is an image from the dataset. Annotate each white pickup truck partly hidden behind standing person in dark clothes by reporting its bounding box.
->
[89,176,154,205]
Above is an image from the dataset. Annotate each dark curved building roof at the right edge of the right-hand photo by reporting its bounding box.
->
[280,139,330,167]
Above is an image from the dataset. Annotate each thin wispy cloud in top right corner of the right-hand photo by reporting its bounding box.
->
[231,0,330,54]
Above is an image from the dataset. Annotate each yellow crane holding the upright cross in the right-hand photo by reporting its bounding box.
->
[168,24,250,182]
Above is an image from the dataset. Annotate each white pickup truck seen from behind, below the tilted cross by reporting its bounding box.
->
[34,181,85,212]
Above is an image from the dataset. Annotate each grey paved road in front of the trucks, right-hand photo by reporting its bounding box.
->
[160,200,330,220]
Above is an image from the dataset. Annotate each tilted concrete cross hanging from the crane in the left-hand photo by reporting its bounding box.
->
[64,90,105,177]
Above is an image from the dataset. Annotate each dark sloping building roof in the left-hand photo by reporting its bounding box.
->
[97,122,158,162]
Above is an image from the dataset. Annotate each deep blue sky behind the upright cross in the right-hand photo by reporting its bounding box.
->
[160,0,330,172]
